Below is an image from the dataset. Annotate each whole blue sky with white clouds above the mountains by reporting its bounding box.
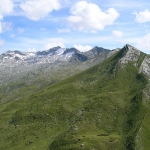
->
[0,0,150,54]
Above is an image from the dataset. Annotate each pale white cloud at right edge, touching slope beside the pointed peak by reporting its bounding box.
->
[136,33,150,53]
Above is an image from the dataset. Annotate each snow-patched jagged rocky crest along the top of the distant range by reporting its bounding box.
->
[0,47,110,66]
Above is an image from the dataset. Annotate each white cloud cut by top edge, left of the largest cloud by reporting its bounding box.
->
[20,0,60,21]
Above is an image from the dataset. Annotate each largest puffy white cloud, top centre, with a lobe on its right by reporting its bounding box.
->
[68,1,119,32]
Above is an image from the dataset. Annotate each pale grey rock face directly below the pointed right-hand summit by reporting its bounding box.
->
[120,45,140,65]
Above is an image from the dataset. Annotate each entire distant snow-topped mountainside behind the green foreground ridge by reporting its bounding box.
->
[0,47,110,103]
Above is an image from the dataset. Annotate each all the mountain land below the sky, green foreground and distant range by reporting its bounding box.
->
[0,44,150,150]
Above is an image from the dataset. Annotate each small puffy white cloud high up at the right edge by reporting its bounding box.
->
[133,9,150,23]
